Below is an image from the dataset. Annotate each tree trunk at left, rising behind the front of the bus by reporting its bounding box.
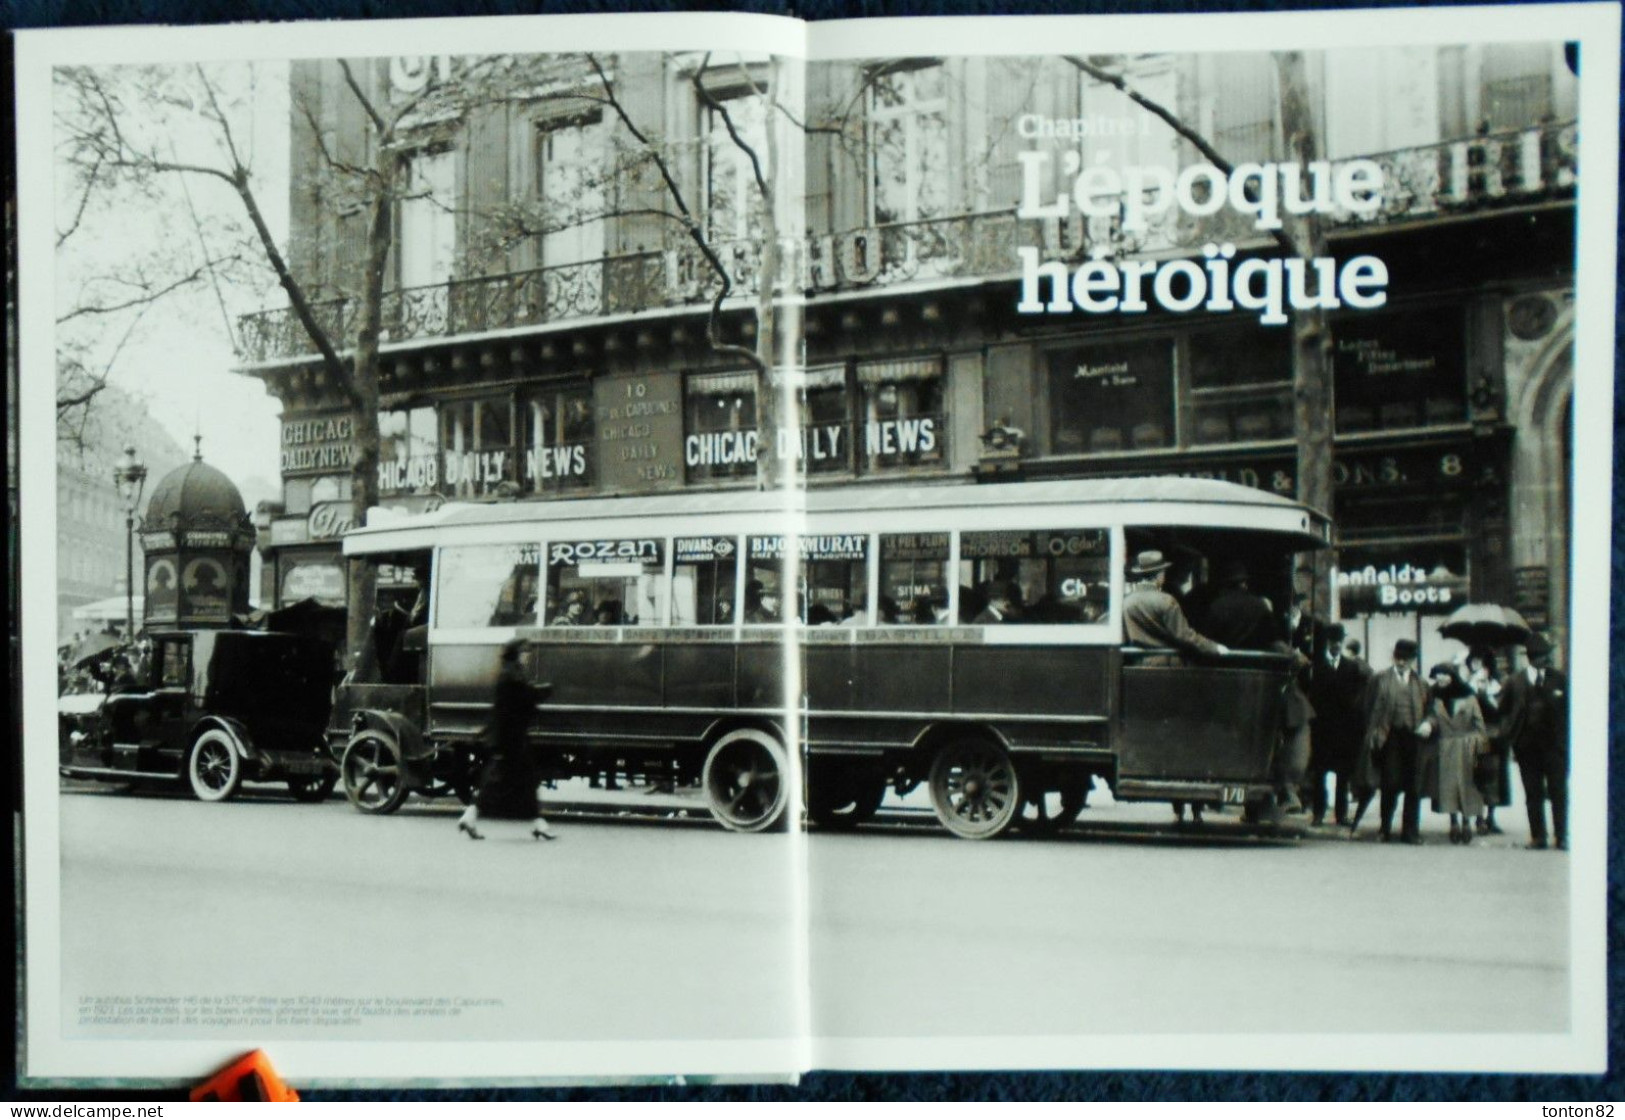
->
[345,140,395,658]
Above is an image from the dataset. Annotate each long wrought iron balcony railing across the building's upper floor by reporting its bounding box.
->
[239,122,1578,362]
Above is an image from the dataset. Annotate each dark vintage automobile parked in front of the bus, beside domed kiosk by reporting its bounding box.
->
[59,631,338,801]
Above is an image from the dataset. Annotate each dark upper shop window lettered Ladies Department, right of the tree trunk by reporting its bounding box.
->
[1331,307,1467,434]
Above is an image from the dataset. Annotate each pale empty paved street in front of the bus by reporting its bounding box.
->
[62,773,1568,1039]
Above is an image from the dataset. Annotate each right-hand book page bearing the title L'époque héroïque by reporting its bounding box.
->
[804,7,1619,1071]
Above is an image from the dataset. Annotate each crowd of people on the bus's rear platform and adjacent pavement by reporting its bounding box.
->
[1123,549,1568,850]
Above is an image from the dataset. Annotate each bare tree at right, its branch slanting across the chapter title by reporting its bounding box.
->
[1066,50,1333,614]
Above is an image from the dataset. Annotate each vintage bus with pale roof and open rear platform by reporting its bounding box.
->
[328,478,1329,839]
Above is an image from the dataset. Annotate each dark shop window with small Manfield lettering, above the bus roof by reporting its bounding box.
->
[1050,340,1173,455]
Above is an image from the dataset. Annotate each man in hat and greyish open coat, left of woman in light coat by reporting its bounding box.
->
[1350,637,1433,844]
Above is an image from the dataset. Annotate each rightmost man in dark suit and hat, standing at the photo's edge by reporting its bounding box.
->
[1502,636,1568,850]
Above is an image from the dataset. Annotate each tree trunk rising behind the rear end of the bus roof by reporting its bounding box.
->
[1276,50,1334,618]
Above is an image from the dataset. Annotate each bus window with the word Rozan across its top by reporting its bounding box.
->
[548,538,666,626]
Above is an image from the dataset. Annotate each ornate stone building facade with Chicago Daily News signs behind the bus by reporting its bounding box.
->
[242,44,1578,663]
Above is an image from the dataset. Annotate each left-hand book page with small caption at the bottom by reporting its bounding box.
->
[18,15,808,1086]
